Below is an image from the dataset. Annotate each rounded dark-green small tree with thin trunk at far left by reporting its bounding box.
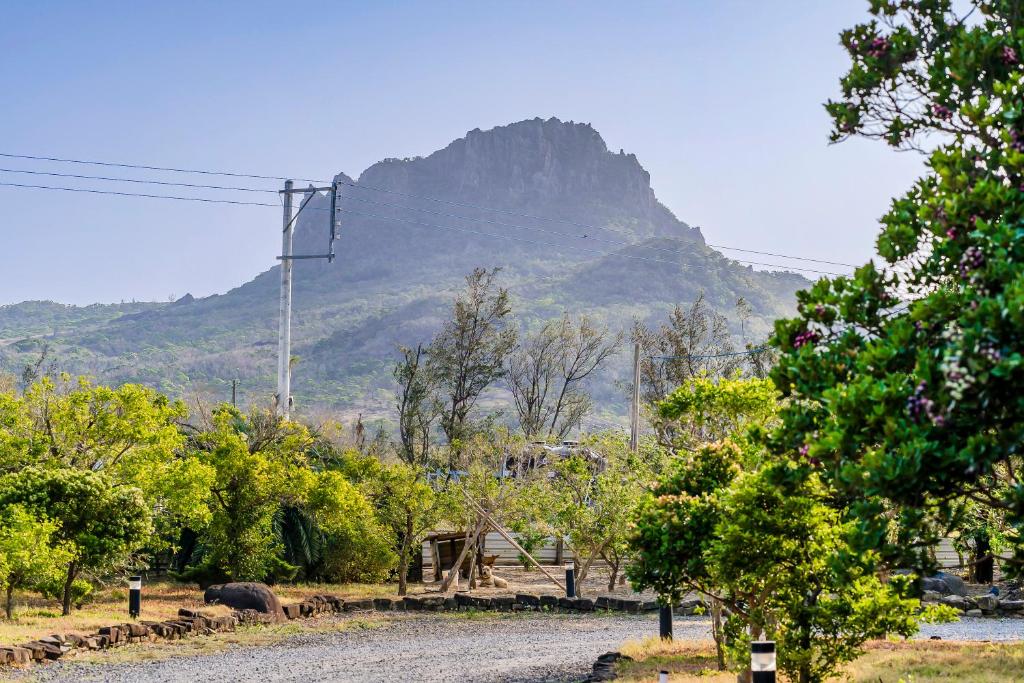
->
[0,467,152,614]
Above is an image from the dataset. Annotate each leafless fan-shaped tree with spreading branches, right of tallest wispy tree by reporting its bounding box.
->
[506,314,622,439]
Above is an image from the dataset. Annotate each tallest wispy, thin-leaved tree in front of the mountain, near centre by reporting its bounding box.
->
[427,268,516,470]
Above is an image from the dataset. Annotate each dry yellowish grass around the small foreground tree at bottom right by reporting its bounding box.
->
[617,638,1024,683]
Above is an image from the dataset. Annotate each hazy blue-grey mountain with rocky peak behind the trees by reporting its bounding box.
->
[0,119,807,414]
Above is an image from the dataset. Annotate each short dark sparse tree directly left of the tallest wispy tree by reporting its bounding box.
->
[393,345,437,466]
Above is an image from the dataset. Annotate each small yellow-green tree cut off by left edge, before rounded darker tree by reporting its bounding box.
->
[0,505,73,618]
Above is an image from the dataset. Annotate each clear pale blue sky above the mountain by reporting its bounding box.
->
[0,0,922,303]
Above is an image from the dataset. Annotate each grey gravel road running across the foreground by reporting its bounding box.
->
[16,612,1024,683]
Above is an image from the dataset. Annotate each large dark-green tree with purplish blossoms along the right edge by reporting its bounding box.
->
[772,0,1024,567]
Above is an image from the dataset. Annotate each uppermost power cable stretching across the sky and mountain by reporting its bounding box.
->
[0,153,857,274]
